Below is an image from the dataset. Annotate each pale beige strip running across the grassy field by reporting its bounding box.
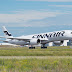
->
[0,56,72,59]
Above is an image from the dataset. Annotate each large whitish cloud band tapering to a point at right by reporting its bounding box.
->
[0,10,63,23]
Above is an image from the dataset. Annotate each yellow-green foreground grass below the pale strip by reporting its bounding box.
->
[0,58,72,72]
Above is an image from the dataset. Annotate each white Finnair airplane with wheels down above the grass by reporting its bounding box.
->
[0,26,72,49]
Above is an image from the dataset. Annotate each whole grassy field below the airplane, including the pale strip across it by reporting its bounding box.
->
[0,46,72,72]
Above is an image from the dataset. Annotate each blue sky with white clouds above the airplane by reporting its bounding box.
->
[0,0,72,36]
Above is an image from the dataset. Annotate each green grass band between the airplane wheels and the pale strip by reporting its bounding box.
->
[0,46,72,56]
